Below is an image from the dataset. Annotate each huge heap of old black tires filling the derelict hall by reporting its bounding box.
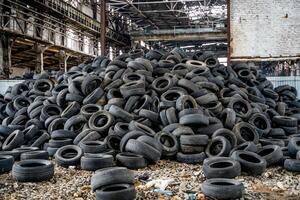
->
[0,48,300,198]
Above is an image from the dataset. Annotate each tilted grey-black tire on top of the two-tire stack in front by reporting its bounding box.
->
[91,167,134,191]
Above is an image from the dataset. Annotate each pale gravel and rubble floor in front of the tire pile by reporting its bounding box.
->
[0,160,300,200]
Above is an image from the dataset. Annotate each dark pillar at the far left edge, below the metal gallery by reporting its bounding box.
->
[0,34,13,79]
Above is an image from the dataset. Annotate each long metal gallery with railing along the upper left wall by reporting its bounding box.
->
[0,0,98,55]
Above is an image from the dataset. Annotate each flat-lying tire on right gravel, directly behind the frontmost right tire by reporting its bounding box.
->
[203,157,241,179]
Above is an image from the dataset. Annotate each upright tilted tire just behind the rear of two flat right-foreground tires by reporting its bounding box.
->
[205,136,231,157]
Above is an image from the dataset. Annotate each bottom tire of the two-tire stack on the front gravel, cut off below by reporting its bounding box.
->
[96,183,136,200]
